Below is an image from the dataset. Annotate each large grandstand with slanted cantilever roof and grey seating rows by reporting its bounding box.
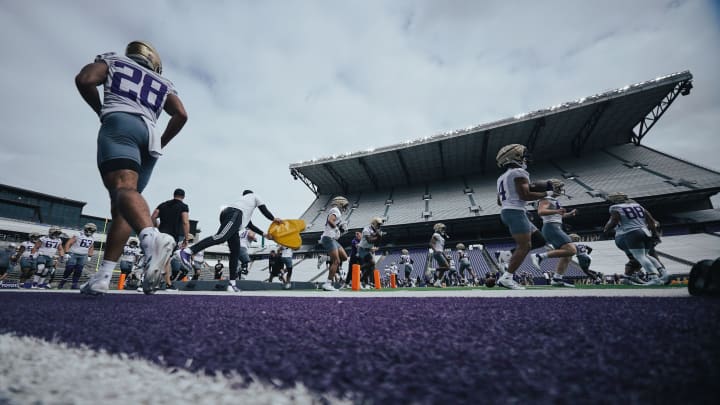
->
[289,71,720,277]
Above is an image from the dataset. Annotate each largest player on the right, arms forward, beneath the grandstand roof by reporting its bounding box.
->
[495,143,555,290]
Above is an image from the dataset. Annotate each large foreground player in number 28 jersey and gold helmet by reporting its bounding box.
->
[75,41,187,295]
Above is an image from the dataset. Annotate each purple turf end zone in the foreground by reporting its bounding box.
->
[0,293,720,404]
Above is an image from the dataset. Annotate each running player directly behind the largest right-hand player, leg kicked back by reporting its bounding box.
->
[533,179,577,287]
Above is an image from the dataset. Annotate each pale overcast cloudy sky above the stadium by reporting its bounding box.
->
[0,0,720,235]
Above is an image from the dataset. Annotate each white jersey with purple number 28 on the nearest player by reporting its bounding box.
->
[95,52,177,124]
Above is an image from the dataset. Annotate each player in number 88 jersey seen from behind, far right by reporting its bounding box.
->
[603,192,664,285]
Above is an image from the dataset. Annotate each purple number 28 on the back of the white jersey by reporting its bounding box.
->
[110,61,167,114]
